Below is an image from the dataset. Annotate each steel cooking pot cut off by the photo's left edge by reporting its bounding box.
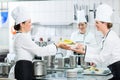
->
[0,62,11,76]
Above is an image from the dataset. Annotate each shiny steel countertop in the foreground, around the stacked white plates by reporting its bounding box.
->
[35,71,112,80]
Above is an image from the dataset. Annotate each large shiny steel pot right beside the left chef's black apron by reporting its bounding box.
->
[33,60,47,77]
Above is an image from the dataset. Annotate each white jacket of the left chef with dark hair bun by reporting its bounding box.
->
[13,33,57,61]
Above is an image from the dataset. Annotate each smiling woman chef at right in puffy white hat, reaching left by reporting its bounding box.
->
[72,4,120,80]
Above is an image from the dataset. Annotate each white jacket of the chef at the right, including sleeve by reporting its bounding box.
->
[85,30,120,66]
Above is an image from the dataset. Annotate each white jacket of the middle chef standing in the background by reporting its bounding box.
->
[71,31,97,46]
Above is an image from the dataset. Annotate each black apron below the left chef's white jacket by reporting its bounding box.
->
[15,60,33,80]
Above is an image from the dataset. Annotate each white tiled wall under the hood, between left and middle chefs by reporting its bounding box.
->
[33,24,77,42]
